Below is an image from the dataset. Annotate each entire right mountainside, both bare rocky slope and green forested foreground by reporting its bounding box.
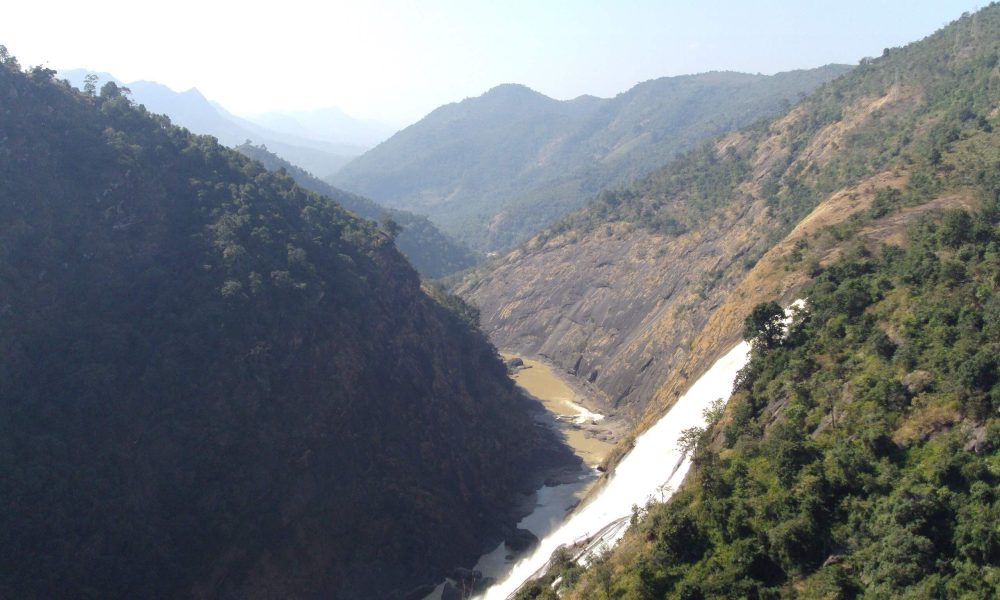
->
[459,4,1000,598]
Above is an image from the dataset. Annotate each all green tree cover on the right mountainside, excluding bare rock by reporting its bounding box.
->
[519,5,1000,599]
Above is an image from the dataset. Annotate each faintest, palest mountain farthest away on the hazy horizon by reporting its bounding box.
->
[249,107,395,149]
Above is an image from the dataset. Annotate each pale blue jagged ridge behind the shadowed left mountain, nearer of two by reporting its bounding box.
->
[59,69,366,174]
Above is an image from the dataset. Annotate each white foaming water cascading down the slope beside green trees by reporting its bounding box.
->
[479,342,750,600]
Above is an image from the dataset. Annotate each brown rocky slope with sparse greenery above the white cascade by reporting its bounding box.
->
[459,9,1000,426]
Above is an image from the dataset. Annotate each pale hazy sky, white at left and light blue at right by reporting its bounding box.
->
[0,0,985,125]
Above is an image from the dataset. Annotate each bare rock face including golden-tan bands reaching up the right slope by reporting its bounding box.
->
[458,173,973,420]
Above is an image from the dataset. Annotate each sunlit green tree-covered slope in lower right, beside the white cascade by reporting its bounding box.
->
[519,205,1000,599]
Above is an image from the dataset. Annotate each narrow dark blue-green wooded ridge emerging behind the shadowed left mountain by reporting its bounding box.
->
[236,144,476,278]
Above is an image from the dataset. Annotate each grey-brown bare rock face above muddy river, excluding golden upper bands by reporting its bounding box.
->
[460,202,767,418]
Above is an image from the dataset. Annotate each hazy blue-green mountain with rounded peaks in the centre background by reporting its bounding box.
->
[328,65,849,251]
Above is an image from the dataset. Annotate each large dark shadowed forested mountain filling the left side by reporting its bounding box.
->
[0,47,543,598]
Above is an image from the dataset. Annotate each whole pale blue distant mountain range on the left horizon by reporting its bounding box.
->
[53,69,391,176]
